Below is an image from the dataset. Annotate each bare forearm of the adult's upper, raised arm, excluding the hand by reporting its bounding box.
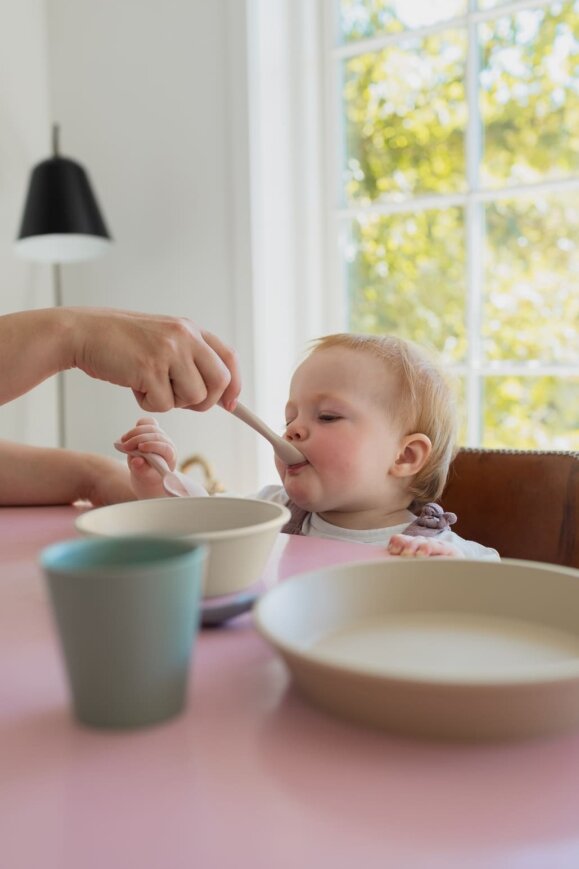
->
[0,308,73,404]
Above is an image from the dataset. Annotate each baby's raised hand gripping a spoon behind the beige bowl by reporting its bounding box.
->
[117,416,177,499]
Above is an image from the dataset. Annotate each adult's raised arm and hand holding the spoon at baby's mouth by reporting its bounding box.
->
[0,308,241,412]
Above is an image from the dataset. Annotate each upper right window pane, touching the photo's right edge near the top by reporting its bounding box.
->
[479,0,579,187]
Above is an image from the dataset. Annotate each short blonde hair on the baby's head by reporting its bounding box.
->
[309,332,456,509]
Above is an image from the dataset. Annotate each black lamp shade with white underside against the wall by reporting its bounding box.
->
[16,156,111,262]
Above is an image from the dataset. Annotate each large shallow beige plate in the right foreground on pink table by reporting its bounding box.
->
[254,559,579,740]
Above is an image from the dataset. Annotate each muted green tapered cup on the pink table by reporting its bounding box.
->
[40,537,207,728]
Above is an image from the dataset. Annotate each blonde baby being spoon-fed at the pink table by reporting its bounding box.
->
[116,333,499,560]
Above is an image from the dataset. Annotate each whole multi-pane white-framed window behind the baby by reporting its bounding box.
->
[330,0,579,449]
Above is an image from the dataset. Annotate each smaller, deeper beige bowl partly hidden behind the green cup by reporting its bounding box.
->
[75,497,290,597]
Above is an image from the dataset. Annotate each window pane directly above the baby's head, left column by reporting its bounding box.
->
[343,208,466,364]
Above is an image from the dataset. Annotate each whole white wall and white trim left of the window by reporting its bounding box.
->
[0,0,326,492]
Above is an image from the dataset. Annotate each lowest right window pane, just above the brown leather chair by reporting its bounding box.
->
[483,377,579,450]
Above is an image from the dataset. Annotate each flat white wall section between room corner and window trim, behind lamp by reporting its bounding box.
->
[43,0,256,492]
